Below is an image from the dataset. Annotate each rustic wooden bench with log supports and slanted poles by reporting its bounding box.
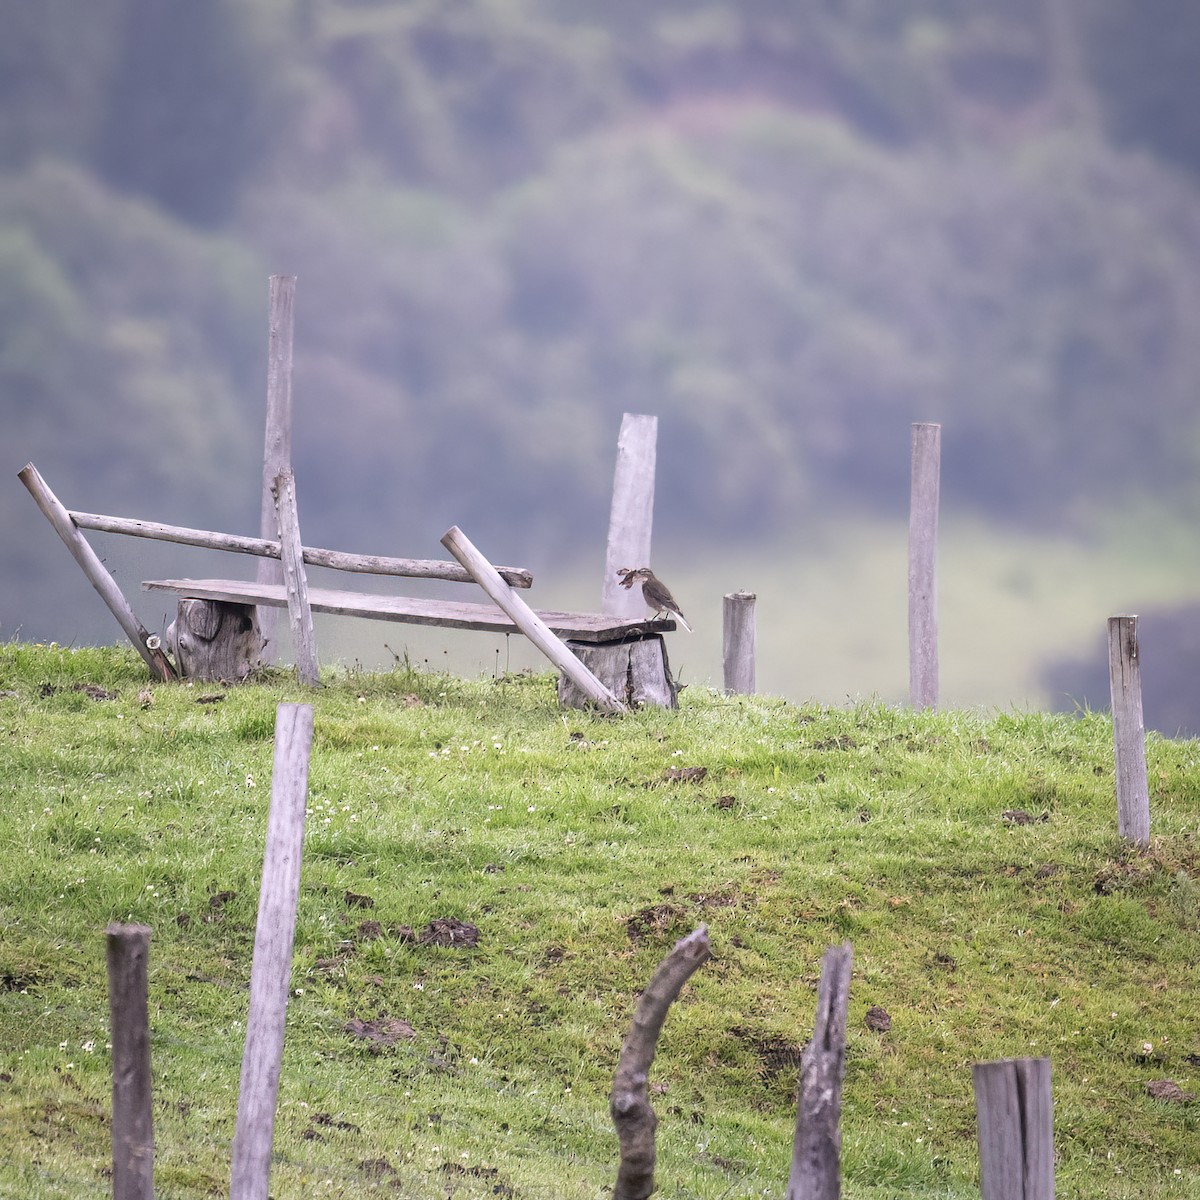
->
[20,464,677,710]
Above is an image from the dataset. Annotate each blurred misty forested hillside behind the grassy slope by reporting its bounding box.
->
[0,0,1200,733]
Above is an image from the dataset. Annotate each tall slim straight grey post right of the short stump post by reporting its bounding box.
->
[908,422,942,708]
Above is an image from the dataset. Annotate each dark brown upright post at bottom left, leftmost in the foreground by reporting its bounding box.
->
[106,924,154,1200]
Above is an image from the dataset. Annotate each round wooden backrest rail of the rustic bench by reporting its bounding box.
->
[70,509,533,588]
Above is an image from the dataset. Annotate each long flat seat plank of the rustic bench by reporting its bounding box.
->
[142,580,676,642]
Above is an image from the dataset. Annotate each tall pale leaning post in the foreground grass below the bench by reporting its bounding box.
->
[229,704,312,1200]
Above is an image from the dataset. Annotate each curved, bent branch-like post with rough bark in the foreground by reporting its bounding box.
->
[608,925,710,1200]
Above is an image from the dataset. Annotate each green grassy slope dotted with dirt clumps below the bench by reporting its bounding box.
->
[0,643,1200,1200]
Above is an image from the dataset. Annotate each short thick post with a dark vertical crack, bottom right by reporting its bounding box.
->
[971,1058,1054,1200]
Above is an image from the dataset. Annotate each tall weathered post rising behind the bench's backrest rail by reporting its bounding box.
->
[256,275,296,656]
